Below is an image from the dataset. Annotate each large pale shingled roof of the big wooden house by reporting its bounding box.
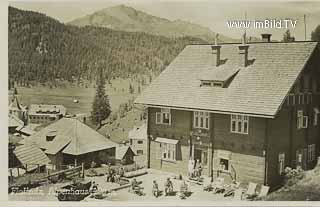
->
[135,42,317,118]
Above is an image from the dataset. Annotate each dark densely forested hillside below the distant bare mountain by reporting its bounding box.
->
[8,7,204,86]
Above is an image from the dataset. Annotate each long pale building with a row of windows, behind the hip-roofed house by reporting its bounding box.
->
[28,104,67,124]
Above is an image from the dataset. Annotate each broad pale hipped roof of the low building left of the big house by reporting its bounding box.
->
[25,118,116,155]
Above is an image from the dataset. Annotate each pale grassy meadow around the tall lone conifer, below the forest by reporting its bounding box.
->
[17,79,149,143]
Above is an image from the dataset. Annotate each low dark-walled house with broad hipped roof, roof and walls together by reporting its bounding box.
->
[24,118,116,169]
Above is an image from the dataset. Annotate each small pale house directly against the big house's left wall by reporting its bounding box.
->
[128,124,147,156]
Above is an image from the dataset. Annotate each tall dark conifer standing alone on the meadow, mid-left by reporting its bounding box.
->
[91,68,111,128]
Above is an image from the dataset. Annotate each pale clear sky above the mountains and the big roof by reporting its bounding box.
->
[9,0,320,40]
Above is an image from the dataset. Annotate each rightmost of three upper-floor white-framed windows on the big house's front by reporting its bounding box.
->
[231,114,249,134]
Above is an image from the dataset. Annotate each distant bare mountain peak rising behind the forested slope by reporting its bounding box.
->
[68,5,235,42]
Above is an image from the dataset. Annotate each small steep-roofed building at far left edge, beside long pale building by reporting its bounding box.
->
[9,95,28,124]
